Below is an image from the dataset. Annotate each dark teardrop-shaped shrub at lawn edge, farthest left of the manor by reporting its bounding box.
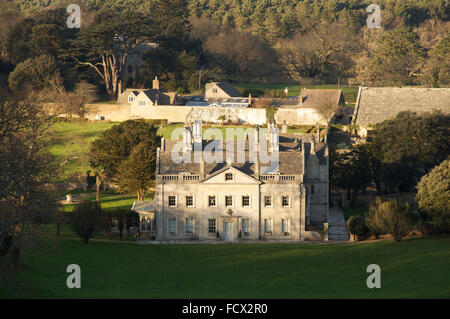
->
[69,201,103,244]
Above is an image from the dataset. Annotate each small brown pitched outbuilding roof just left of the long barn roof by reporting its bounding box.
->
[299,88,345,107]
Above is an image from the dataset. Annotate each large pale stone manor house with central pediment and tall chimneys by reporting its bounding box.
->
[142,121,329,241]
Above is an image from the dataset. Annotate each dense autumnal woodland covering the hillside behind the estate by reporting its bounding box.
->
[0,0,450,99]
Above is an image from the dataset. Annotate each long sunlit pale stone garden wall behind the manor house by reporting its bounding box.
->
[86,104,323,125]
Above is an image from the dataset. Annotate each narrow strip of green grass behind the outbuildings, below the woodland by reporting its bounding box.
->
[233,83,358,102]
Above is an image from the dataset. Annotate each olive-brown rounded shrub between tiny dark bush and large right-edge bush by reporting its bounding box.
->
[367,197,416,242]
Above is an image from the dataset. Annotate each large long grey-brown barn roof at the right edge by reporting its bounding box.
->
[353,87,450,126]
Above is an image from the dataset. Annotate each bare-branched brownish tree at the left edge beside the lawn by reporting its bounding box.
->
[0,101,56,268]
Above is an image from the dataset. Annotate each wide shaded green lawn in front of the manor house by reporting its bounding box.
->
[0,238,450,298]
